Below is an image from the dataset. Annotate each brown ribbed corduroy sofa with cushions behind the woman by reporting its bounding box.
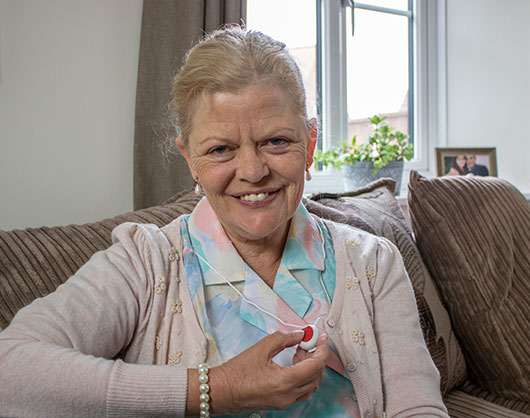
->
[0,171,530,418]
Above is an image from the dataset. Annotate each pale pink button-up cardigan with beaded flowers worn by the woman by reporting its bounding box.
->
[0,219,448,417]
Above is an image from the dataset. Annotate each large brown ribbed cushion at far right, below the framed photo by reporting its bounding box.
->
[409,172,530,402]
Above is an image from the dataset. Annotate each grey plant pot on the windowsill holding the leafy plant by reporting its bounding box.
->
[342,161,404,194]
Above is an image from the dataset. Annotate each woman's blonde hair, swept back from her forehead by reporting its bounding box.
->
[171,26,309,147]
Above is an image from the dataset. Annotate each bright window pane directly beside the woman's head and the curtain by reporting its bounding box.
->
[246,0,317,117]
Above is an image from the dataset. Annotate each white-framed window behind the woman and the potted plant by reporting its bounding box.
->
[247,0,445,192]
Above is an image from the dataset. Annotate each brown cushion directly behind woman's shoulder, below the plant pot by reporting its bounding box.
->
[305,179,466,393]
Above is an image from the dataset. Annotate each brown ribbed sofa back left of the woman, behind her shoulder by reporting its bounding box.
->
[0,191,200,329]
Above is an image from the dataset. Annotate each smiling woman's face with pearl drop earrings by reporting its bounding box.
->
[177,85,316,245]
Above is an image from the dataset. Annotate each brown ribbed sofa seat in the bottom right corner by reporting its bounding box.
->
[445,390,529,418]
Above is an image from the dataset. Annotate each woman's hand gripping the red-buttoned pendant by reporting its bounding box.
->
[210,331,329,415]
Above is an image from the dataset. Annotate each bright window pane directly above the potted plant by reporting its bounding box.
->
[346,7,409,142]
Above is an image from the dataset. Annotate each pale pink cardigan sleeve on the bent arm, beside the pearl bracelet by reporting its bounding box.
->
[0,224,187,417]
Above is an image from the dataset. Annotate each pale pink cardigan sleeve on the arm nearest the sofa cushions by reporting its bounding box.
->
[372,239,448,418]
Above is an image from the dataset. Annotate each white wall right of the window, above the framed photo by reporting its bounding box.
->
[447,0,530,193]
